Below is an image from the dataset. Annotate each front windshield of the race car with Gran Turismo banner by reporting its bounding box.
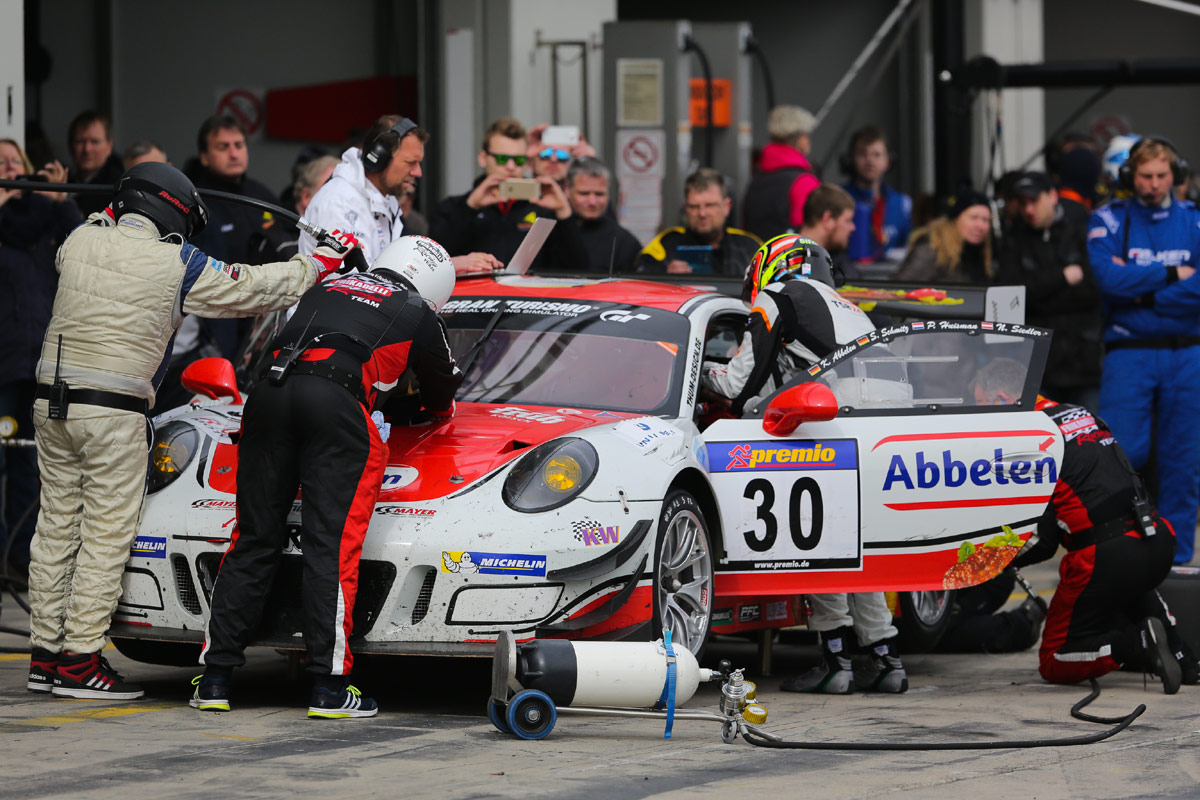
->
[442,297,689,415]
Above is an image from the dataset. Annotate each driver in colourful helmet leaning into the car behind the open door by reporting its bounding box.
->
[701,234,908,694]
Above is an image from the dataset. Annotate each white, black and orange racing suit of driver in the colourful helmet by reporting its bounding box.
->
[701,279,896,645]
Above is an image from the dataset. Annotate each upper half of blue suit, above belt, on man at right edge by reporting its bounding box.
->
[1087,198,1200,342]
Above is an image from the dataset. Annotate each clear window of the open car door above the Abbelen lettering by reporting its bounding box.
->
[800,321,1050,413]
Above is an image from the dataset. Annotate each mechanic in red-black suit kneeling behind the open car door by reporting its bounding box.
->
[974,359,1200,694]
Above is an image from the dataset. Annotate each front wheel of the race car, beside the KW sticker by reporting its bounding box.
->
[650,491,714,661]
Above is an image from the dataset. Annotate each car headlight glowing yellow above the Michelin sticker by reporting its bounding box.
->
[503,439,600,512]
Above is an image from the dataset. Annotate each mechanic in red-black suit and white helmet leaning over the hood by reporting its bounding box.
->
[191,236,462,718]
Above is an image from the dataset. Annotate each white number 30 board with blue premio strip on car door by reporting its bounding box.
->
[706,439,863,571]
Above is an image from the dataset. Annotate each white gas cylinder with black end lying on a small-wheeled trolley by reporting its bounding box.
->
[493,639,713,708]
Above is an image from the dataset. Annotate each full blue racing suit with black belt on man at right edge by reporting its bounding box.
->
[1087,196,1200,564]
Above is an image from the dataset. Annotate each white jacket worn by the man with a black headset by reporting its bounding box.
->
[300,148,404,264]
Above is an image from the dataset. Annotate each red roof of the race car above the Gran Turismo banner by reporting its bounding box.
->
[454,275,719,312]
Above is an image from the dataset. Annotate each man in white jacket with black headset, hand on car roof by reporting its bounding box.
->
[300,114,504,275]
